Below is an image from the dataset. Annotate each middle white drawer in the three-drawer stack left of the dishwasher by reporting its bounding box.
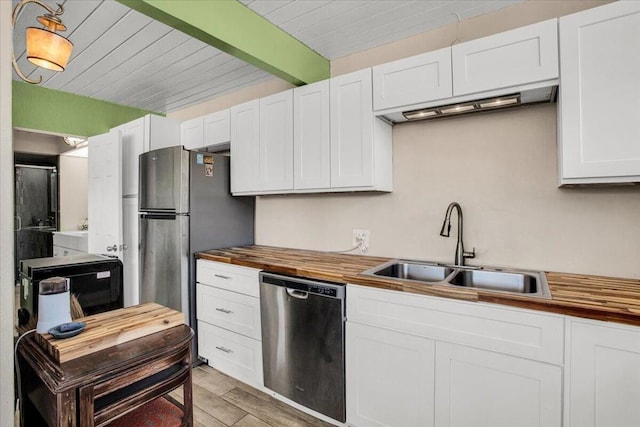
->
[196,283,261,340]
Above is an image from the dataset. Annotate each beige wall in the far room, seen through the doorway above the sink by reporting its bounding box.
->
[58,156,89,231]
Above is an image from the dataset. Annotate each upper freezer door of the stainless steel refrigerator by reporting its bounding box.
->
[139,146,189,213]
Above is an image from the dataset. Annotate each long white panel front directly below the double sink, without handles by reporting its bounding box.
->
[347,285,564,365]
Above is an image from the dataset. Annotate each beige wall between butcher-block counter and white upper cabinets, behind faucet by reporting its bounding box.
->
[256,104,640,278]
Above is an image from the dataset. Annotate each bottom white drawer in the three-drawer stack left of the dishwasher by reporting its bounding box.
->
[198,321,264,387]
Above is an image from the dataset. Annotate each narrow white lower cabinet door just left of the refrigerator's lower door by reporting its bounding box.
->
[122,197,140,307]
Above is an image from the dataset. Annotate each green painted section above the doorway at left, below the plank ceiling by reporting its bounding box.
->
[12,80,162,136]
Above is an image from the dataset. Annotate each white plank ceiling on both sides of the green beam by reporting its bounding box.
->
[13,0,523,113]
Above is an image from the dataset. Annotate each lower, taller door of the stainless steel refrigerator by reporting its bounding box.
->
[140,214,189,321]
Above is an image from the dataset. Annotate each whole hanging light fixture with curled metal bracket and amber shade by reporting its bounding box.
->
[11,0,73,84]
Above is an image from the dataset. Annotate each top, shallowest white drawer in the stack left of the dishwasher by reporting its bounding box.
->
[196,259,260,297]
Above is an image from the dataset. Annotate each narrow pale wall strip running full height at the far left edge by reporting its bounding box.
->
[0,1,15,427]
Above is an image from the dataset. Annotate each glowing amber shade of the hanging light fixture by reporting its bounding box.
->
[27,27,73,71]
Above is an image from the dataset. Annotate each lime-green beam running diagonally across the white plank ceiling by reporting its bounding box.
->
[118,0,330,86]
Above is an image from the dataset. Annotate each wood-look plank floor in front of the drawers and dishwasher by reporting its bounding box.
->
[170,365,331,427]
